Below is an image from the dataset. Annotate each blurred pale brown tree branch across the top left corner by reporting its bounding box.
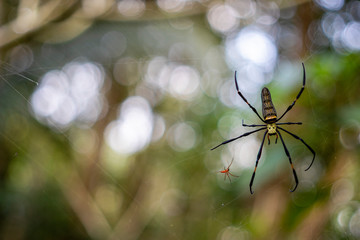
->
[0,0,309,50]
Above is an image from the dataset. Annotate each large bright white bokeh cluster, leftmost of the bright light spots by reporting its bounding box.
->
[31,62,104,129]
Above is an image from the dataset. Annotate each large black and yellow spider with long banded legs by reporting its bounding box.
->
[211,63,315,194]
